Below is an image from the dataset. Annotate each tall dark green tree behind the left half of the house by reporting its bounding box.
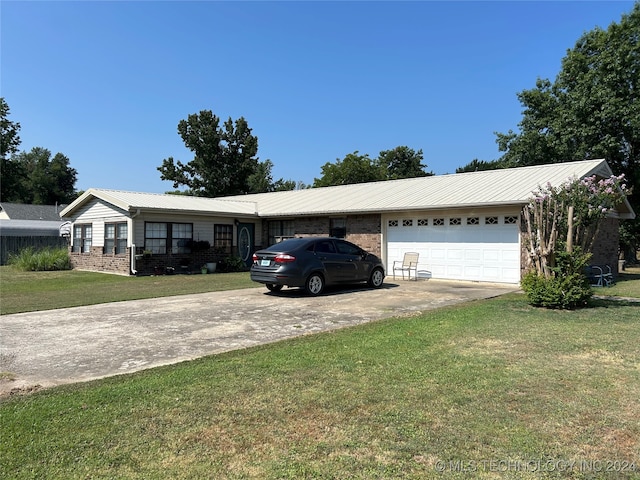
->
[158,110,294,197]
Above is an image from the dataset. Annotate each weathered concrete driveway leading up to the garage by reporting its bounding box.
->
[0,277,518,395]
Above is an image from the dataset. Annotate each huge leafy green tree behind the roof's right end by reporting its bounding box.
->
[458,2,640,254]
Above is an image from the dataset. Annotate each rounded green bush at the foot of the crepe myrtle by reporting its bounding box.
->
[520,249,593,310]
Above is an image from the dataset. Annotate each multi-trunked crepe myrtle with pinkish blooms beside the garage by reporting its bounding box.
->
[523,174,631,278]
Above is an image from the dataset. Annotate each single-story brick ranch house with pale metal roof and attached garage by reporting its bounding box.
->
[61,160,635,283]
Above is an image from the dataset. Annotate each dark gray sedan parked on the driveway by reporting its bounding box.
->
[251,237,384,295]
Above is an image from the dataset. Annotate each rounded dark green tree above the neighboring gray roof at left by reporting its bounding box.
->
[3,147,78,205]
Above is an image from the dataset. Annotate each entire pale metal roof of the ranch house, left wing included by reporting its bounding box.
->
[61,159,635,218]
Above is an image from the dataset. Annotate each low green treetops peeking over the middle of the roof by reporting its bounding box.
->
[313,146,433,187]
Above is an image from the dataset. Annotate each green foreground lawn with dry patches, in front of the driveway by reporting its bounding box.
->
[0,294,640,479]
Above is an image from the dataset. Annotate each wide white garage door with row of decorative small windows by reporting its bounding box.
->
[387,215,520,283]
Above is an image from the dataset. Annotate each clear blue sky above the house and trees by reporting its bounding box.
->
[0,0,633,193]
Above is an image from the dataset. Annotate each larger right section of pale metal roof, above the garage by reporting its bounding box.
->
[225,160,633,218]
